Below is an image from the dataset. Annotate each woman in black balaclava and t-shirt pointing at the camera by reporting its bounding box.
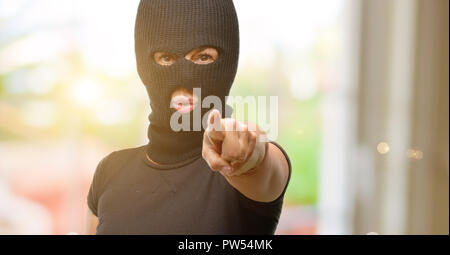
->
[88,0,291,234]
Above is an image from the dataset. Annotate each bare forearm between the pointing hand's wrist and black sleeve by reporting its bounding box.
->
[224,143,289,202]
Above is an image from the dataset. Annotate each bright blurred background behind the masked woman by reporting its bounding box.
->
[0,0,449,234]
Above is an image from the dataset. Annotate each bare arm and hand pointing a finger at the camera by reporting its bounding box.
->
[202,110,289,202]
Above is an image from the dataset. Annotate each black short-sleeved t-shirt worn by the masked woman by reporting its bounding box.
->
[87,143,291,235]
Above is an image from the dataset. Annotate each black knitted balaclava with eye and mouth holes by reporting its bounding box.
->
[135,0,239,164]
